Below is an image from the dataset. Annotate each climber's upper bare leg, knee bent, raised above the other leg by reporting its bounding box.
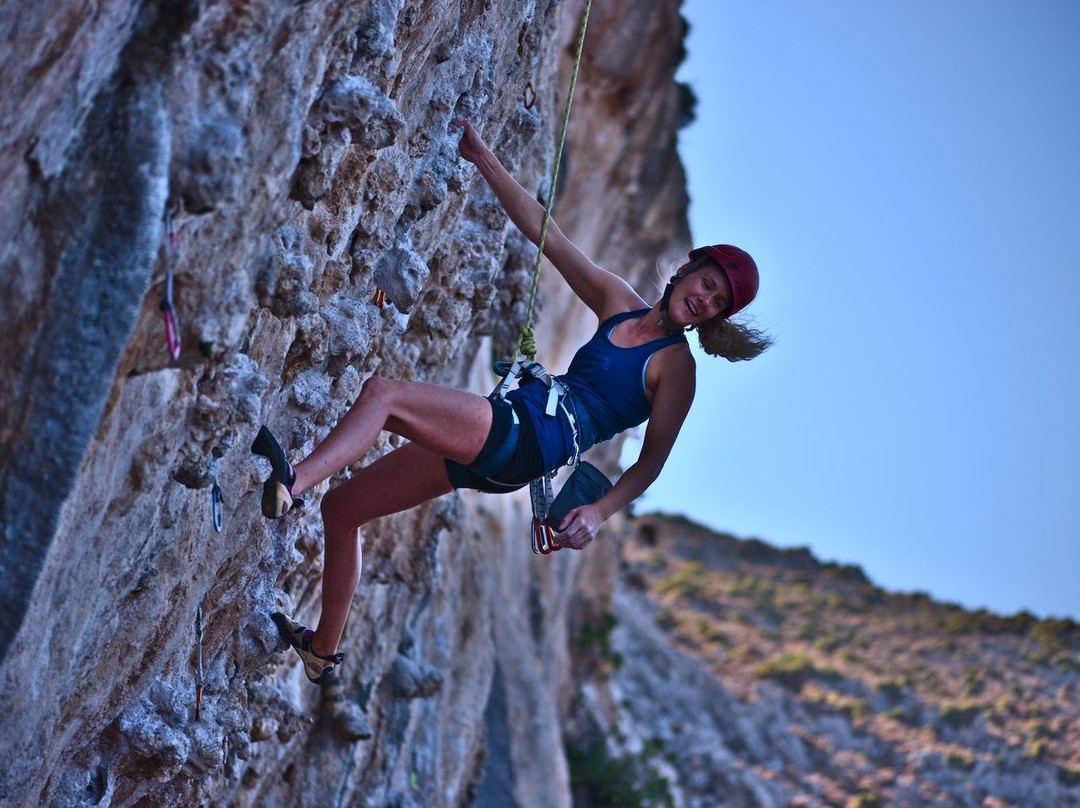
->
[293,376,491,496]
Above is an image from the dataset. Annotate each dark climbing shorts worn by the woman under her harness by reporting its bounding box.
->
[446,399,543,494]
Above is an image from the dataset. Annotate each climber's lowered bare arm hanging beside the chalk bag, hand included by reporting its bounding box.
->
[556,350,694,550]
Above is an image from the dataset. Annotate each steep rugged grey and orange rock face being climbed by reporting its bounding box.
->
[0,0,688,806]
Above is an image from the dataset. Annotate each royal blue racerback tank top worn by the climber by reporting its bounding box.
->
[507,309,686,469]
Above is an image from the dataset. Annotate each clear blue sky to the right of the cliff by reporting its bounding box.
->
[638,0,1080,618]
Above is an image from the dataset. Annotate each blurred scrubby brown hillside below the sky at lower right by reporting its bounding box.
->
[570,514,1080,808]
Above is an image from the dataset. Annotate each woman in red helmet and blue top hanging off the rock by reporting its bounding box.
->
[252,121,771,684]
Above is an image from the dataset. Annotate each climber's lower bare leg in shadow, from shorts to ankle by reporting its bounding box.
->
[311,443,453,656]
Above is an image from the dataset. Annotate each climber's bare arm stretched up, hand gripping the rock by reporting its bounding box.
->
[454,121,645,320]
